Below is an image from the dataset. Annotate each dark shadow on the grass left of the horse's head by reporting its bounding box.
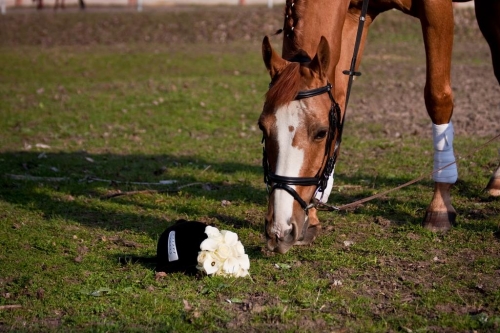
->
[0,152,266,236]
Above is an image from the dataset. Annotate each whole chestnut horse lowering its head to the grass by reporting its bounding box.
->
[259,0,500,253]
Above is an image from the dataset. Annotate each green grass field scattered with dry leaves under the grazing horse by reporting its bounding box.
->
[0,5,500,332]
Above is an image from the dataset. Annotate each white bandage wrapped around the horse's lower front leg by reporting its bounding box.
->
[432,122,458,184]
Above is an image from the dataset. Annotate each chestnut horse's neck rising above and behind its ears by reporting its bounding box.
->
[282,0,350,82]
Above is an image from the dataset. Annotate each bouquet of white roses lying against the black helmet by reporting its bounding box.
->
[196,226,250,277]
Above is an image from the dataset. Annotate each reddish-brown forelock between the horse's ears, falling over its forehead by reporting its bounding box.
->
[265,62,300,110]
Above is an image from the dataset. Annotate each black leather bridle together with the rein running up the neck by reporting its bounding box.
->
[262,0,369,215]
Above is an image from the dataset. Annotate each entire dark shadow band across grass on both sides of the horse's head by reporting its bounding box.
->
[0,152,497,239]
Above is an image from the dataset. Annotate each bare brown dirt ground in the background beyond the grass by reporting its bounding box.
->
[0,6,500,137]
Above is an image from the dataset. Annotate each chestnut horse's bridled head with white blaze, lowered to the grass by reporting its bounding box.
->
[259,37,340,253]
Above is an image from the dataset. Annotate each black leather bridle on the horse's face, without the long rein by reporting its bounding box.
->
[262,83,343,215]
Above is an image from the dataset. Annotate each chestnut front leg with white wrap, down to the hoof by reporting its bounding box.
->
[418,1,458,232]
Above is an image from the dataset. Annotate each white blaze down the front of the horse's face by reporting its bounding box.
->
[272,101,304,237]
